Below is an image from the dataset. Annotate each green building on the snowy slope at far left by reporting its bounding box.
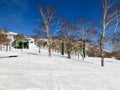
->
[12,39,29,49]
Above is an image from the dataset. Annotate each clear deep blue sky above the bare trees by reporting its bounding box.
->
[0,0,107,35]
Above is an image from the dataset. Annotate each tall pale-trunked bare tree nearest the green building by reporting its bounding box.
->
[39,4,56,57]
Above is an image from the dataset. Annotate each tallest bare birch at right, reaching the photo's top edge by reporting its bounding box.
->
[99,0,120,66]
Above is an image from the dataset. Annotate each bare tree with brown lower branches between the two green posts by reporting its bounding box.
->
[58,17,73,59]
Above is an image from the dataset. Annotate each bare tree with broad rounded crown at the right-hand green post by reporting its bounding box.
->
[75,18,96,60]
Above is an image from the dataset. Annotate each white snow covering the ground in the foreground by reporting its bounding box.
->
[0,44,120,90]
